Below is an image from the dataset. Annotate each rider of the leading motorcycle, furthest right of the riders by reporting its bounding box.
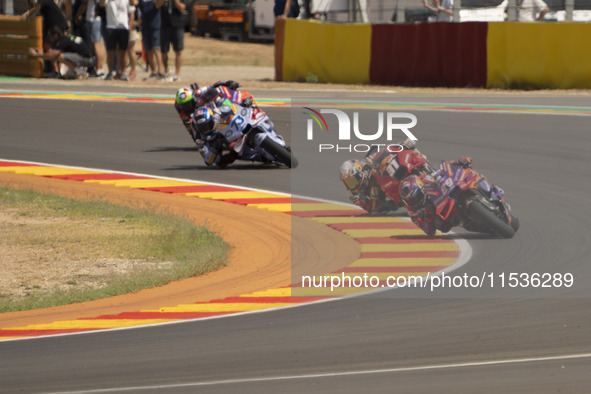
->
[400,157,472,237]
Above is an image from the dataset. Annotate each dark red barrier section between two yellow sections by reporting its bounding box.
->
[370,22,488,87]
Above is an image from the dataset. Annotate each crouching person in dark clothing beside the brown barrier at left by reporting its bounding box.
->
[29,27,94,76]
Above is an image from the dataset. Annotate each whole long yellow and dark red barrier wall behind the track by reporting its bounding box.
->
[275,19,591,89]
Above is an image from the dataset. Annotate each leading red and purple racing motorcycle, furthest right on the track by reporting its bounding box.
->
[426,161,519,238]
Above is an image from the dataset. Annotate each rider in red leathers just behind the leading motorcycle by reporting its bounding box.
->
[339,139,430,214]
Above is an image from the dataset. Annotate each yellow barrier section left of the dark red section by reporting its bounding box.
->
[281,19,371,84]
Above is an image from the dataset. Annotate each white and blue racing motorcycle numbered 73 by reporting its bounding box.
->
[211,86,298,168]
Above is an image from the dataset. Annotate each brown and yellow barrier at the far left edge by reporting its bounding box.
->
[0,16,43,78]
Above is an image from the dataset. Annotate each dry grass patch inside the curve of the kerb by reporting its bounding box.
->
[0,188,228,312]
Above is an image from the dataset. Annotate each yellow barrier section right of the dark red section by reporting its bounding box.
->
[487,22,591,89]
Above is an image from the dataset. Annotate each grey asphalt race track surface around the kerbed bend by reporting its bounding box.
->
[0,85,591,393]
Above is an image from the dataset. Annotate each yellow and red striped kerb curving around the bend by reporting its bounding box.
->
[0,161,460,340]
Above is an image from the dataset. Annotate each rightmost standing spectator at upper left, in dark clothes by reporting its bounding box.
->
[160,0,187,82]
